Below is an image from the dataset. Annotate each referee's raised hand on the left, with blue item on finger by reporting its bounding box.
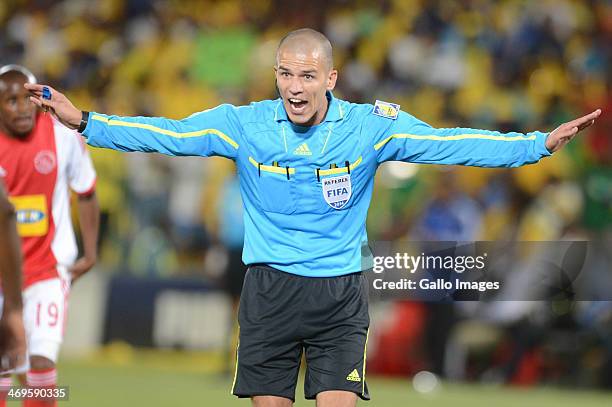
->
[23,83,82,129]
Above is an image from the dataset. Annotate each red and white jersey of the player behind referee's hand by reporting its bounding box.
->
[0,113,96,288]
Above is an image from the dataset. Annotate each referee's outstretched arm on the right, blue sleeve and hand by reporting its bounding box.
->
[367,107,601,167]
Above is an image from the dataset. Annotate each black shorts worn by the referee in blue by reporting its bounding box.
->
[232,265,370,401]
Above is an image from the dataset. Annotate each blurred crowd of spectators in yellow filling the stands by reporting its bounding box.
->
[0,0,612,390]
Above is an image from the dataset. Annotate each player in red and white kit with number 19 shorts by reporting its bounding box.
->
[0,65,99,407]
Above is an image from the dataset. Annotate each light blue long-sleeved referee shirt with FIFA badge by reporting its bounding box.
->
[83,92,550,277]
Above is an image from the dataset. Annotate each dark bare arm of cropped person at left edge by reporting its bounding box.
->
[0,181,26,376]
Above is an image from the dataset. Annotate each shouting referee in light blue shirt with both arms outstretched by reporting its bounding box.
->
[26,29,601,407]
